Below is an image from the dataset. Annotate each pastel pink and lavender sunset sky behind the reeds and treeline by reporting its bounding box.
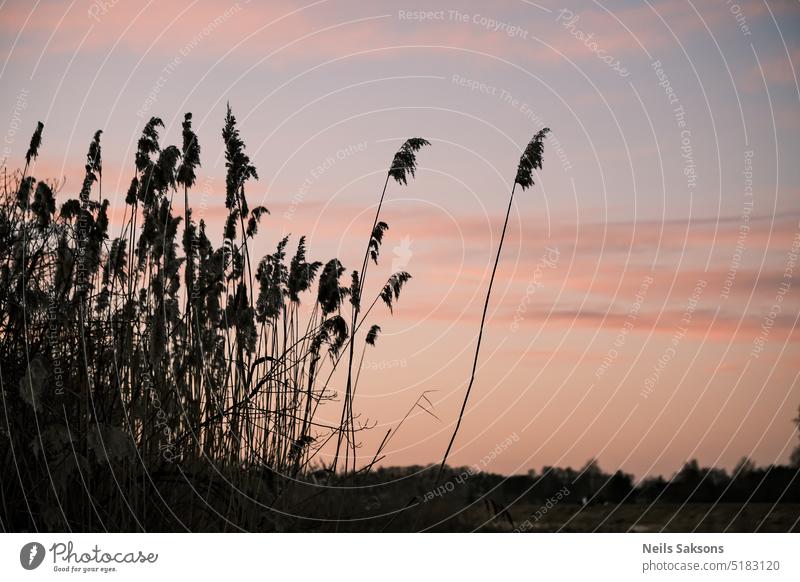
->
[0,0,800,477]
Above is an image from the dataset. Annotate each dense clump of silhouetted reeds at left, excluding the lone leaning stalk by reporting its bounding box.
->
[0,107,428,530]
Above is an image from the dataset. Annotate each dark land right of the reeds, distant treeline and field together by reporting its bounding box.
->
[236,459,800,531]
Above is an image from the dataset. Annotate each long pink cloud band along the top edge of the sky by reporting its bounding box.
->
[0,0,732,72]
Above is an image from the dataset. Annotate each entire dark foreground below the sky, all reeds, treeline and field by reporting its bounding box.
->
[0,113,800,531]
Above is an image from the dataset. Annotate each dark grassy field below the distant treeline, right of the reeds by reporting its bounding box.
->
[262,482,800,533]
